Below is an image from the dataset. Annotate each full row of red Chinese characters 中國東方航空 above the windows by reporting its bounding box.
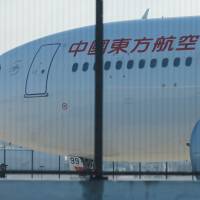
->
[69,35,200,57]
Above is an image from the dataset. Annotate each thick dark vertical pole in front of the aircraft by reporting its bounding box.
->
[94,0,103,179]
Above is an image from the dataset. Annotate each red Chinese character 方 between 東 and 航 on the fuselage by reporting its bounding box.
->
[131,37,153,53]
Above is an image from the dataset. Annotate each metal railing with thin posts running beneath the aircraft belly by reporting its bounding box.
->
[0,148,197,179]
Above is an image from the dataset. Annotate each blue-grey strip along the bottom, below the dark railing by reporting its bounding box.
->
[0,180,200,200]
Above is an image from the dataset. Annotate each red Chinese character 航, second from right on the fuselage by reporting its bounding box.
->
[152,36,176,52]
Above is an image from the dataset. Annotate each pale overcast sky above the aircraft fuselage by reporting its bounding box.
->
[0,0,200,54]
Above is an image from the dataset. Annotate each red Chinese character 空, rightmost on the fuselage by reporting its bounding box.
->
[176,35,199,51]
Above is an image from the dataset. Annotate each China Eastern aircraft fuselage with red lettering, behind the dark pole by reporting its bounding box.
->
[0,17,200,165]
